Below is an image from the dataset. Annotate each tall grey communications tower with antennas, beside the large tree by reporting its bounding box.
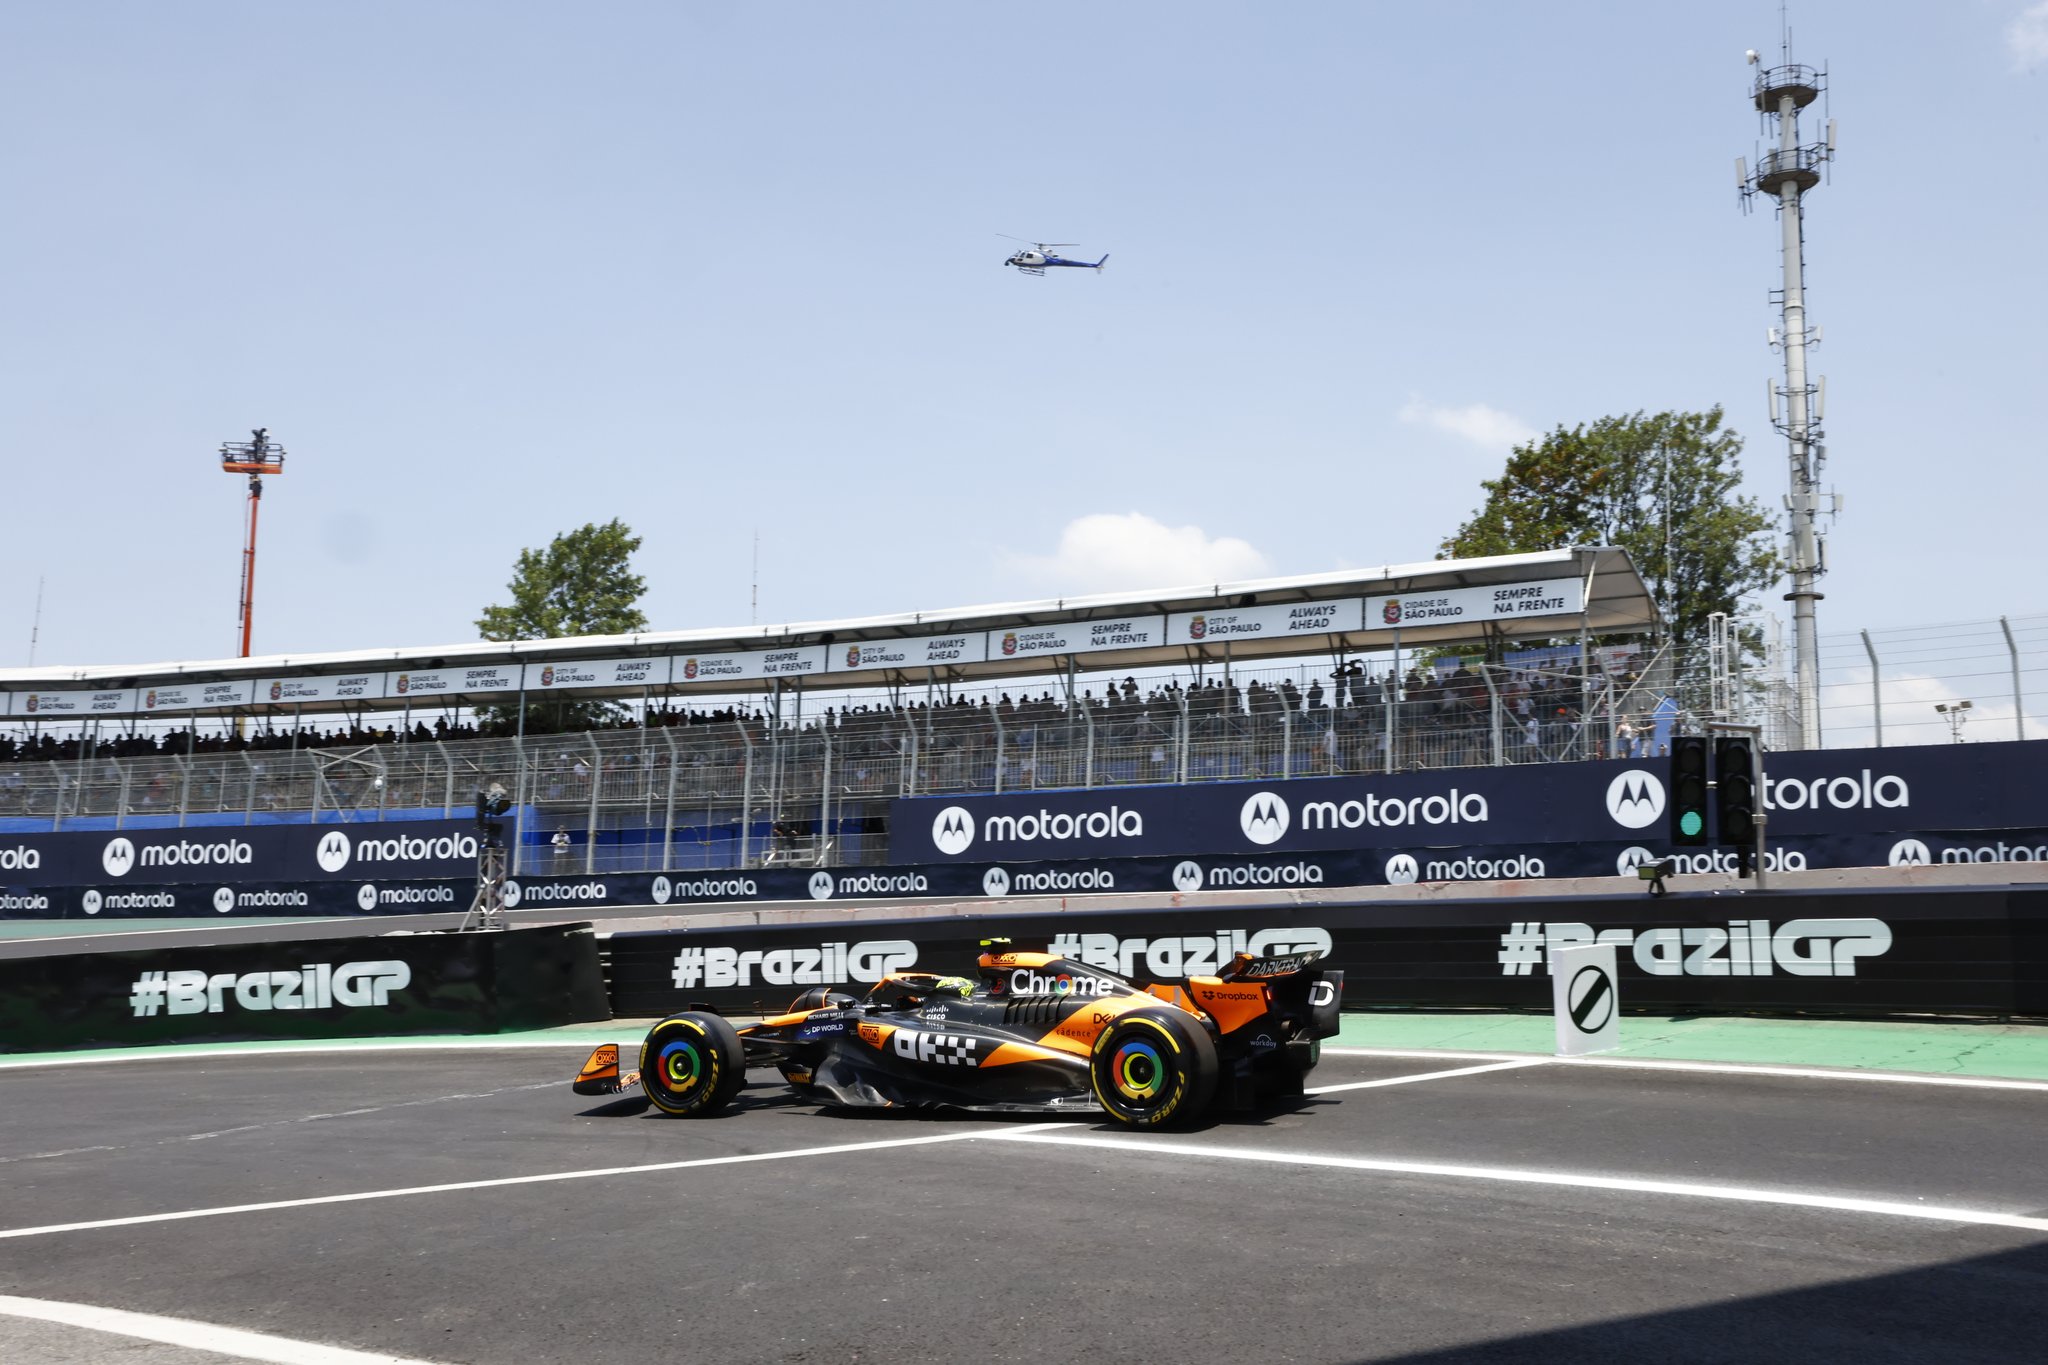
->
[1735,29,1839,749]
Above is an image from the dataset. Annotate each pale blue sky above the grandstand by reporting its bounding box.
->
[0,0,2048,665]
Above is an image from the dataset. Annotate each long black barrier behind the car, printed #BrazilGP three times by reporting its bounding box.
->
[608,888,2048,1017]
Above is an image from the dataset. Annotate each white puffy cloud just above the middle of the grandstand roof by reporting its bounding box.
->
[1001,512,1272,596]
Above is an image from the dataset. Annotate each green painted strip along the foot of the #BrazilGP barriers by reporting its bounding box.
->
[0,1009,2048,1081]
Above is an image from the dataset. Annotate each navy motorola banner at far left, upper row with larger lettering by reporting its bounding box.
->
[0,821,477,892]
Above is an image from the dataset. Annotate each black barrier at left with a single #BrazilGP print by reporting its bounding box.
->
[0,923,610,1052]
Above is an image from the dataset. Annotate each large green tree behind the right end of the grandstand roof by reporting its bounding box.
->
[1438,407,1780,647]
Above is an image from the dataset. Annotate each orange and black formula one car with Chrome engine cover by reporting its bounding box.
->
[575,939,1343,1128]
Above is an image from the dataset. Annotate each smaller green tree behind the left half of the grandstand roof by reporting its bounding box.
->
[477,518,647,733]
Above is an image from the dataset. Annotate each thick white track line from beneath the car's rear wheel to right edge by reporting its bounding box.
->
[989,1130,2048,1232]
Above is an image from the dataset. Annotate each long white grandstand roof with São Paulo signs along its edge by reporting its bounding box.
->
[0,546,1657,720]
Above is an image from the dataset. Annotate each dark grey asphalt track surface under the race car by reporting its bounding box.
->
[0,1044,2048,1365]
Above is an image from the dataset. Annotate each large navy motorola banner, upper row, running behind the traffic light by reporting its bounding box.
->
[889,741,2048,866]
